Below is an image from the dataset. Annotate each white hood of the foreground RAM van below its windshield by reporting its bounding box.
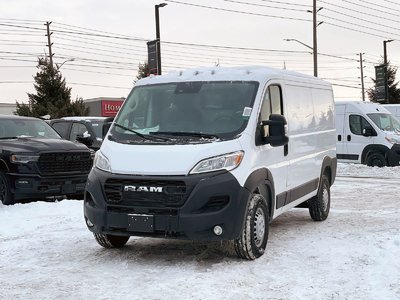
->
[100,139,242,175]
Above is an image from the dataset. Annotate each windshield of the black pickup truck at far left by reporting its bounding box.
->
[0,119,61,139]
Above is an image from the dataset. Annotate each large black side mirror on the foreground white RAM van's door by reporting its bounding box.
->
[262,114,289,147]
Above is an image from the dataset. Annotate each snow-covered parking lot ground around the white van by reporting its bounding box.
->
[0,164,400,300]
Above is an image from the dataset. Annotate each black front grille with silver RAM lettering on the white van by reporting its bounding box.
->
[104,179,187,208]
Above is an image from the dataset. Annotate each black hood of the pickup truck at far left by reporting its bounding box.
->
[0,137,88,153]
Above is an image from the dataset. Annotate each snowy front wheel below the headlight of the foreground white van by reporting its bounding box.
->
[234,194,269,260]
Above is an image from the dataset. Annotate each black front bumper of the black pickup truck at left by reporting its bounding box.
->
[8,173,87,200]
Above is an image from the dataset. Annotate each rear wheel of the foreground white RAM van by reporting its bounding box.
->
[308,174,331,221]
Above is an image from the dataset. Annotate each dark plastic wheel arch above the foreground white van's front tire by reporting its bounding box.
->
[244,168,275,220]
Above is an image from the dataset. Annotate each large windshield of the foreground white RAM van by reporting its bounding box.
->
[111,81,258,141]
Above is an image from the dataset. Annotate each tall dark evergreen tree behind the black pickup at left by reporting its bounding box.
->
[16,57,89,119]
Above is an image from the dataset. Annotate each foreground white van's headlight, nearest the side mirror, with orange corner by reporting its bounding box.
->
[189,151,244,174]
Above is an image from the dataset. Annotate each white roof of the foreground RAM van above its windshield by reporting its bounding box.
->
[136,66,331,87]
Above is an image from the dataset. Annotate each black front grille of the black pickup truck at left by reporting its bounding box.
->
[38,152,93,175]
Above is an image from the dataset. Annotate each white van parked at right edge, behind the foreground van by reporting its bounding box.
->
[335,101,400,167]
